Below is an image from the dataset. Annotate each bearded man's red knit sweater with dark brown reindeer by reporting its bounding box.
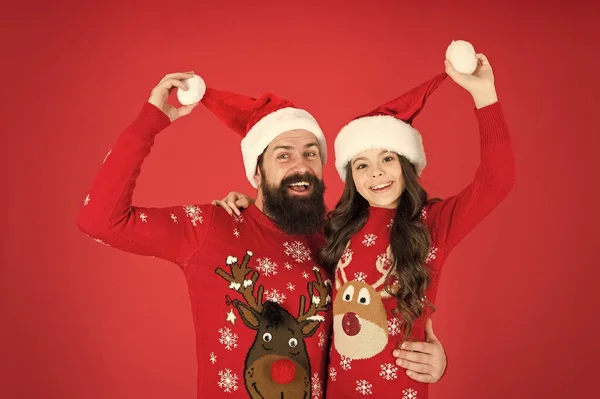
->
[78,103,331,399]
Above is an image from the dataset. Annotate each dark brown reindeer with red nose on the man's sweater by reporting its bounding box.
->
[215,248,331,398]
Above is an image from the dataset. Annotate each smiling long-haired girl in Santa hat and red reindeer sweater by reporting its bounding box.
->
[321,54,515,399]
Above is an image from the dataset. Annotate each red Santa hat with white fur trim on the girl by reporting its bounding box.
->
[334,72,448,181]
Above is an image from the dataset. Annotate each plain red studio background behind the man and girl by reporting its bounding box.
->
[0,0,600,399]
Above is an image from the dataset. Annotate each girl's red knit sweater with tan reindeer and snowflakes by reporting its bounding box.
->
[327,103,515,399]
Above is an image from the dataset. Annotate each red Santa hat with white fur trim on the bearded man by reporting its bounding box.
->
[181,78,327,188]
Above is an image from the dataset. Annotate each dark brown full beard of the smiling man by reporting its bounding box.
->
[262,172,325,235]
